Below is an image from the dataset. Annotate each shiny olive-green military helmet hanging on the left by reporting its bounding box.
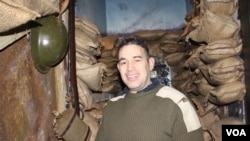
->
[30,15,68,73]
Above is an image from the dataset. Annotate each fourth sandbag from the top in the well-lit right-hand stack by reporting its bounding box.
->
[199,56,244,85]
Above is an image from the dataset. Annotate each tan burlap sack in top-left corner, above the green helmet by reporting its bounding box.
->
[0,0,59,32]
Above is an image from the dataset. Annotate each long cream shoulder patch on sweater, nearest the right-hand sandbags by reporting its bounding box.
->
[156,86,201,132]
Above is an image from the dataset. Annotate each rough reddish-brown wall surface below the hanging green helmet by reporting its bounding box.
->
[0,37,57,141]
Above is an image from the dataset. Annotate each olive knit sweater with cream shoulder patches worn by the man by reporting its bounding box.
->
[96,85,204,141]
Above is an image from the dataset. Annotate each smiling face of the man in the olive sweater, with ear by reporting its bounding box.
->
[117,44,154,93]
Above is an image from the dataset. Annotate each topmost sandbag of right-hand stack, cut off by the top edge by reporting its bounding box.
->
[201,0,238,15]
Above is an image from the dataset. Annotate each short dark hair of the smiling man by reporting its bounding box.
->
[114,37,150,57]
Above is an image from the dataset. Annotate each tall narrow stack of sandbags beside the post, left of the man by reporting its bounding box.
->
[75,17,105,141]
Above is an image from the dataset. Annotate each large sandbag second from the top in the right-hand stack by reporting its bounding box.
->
[186,10,240,43]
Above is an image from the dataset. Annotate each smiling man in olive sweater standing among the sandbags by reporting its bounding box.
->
[96,38,204,141]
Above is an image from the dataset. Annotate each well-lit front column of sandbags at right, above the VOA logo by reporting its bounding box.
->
[182,0,246,105]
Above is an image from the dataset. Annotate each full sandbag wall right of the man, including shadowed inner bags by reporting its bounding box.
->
[176,0,246,140]
